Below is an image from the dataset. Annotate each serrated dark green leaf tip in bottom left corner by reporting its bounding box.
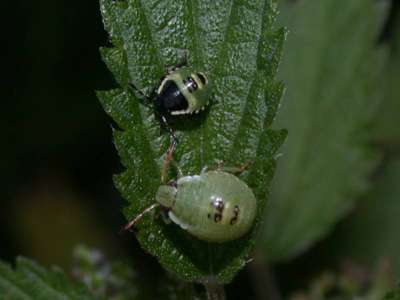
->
[0,257,95,300]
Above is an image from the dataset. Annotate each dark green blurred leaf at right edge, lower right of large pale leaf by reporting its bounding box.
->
[325,159,400,277]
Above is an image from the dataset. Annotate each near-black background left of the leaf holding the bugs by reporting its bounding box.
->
[0,0,400,295]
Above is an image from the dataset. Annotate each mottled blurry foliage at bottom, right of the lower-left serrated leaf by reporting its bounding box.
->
[73,246,198,300]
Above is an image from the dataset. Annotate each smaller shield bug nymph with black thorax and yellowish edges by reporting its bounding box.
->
[156,67,210,115]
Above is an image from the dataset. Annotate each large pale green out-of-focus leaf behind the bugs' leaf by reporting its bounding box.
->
[263,0,387,261]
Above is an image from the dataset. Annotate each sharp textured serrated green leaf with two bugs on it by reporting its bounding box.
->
[98,0,286,283]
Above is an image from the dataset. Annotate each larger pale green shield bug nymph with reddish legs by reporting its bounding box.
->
[125,159,257,243]
